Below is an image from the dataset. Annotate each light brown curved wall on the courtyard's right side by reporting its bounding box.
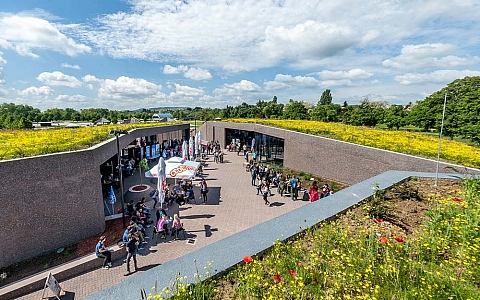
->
[199,122,480,184]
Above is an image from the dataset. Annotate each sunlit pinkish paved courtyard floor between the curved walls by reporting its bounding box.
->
[15,152,308,300]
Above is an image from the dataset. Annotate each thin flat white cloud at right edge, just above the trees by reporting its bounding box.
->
[395,70,480,85]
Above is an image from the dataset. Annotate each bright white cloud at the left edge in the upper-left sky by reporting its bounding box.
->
[0,15,91,58]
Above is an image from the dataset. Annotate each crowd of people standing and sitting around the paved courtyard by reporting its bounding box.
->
[95,142,333,276]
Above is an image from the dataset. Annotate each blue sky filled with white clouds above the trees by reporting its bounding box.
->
[0,0,480,111]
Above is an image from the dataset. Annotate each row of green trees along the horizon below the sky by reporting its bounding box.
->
[0,76,480,143]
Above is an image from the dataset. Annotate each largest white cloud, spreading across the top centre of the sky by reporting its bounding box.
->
[79,0,372,74]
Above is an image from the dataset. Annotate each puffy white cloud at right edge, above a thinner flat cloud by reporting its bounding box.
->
[382,43,480,70]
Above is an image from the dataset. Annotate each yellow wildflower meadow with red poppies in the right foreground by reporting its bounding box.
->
[149,179,480,300]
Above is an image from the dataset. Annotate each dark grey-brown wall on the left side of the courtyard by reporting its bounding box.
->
[0,124,190,268]
